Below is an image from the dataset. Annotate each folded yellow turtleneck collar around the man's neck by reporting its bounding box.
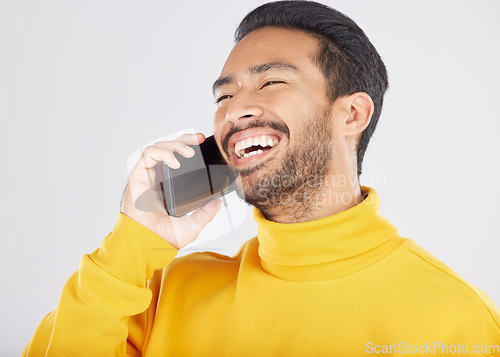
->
[253,186,405,281]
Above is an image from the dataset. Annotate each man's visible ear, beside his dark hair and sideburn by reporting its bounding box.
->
[341,92,374,136]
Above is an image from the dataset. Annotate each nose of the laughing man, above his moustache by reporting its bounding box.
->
[224,89,264,126]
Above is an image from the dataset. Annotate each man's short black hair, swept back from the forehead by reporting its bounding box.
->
[234,0,389,177]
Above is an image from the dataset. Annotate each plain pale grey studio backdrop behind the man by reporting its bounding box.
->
[0,0,500,356]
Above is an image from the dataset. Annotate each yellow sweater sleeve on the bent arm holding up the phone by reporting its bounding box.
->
[22,212,178,357]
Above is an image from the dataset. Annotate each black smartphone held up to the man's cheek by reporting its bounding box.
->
[136,135,236,217]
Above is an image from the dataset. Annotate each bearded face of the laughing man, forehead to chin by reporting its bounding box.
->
[214,27,333,220]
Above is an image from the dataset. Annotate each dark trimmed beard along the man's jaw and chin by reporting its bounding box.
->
[238,110,333,222]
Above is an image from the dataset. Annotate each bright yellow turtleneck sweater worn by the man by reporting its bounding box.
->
[23,186,500,357]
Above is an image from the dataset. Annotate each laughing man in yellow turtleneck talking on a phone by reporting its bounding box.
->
[23,1,500,356]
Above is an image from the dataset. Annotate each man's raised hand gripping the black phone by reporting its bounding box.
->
[120,133,222,249]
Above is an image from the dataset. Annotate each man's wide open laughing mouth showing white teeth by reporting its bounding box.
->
[234,135,280,165]
